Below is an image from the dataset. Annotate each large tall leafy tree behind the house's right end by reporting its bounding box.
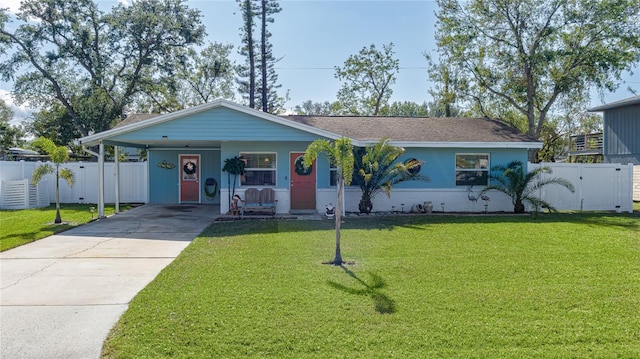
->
[436,0,640,137]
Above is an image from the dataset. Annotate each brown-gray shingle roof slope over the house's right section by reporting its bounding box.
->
[283,116,538,142]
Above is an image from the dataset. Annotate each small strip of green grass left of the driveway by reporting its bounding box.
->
[0,203,130,252]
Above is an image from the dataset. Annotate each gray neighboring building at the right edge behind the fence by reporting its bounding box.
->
[588,96,640,165]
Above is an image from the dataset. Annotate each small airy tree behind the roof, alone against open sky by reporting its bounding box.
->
[335,43,400,116]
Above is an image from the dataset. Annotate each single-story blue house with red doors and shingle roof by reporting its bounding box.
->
[79,100,542,214]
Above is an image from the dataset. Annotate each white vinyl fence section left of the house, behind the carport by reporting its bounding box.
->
[0,161,149,209]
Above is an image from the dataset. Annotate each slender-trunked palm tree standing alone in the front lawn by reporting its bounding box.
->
[304,137,354,266]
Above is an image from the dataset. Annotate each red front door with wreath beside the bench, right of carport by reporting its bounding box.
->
[289,153,316,209]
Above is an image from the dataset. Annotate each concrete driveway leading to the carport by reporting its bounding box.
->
[0,205,219,359]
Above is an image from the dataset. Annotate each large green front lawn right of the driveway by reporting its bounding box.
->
[103,214,640,358]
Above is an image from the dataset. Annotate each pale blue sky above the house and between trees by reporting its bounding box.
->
[0,0,640,123]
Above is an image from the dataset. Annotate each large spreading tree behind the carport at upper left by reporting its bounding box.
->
[0,0,205,140]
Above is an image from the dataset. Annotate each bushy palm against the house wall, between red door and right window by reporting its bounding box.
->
[354,138,430,213]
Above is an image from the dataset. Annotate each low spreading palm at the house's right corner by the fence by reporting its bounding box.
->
[480,161,575,213]
